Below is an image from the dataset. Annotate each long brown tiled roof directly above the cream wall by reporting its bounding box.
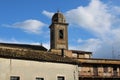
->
[0,47,80,64]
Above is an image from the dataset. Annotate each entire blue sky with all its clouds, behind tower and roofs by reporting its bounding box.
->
[0,0,120,58]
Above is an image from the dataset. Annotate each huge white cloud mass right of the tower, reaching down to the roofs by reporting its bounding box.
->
[65,0,120,58]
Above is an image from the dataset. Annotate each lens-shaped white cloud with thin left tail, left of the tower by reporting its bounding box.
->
[3,19,46,34]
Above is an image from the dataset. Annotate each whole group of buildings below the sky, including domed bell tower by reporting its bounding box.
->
[0,11,120,80]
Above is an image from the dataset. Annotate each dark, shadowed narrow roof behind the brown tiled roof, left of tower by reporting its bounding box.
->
[0,43,47,51]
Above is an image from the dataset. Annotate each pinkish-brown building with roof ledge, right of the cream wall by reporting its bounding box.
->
[78,58,120,80]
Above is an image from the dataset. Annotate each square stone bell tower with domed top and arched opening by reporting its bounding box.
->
[49,11,68,50]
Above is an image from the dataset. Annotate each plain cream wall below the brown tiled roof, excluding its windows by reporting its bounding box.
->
[0,58,78,80]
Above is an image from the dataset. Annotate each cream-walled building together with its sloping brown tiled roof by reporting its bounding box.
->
[0,46,78,80]
